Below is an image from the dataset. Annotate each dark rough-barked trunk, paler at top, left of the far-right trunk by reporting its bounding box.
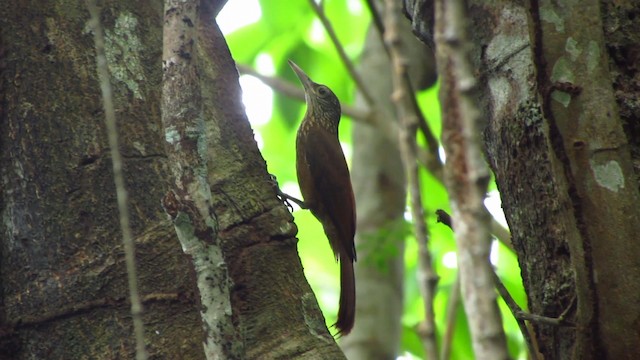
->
[470,2,587,358]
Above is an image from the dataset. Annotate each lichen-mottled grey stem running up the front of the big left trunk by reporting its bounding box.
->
[160,0,245,360]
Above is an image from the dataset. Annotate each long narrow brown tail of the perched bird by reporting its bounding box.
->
[333,258,356,336]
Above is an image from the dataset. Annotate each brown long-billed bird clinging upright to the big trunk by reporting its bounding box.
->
[289,60,357,336]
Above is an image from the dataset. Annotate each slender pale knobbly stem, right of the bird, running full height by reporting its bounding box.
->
[384,0,438,359]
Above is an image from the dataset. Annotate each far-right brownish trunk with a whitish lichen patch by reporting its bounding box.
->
[530,0,640,359]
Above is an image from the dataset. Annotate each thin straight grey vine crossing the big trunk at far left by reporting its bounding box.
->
[87,0,148,360]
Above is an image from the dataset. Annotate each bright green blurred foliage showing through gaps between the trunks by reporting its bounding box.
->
[221,0,526,359]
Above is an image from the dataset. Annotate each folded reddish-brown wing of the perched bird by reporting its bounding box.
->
[301,129,356,261]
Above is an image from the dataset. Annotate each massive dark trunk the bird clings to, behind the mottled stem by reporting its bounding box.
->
[0,1,342,359]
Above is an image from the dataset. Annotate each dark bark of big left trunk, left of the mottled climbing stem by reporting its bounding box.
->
[0,1,202,359]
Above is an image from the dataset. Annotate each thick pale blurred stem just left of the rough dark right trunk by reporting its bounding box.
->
[435,0,509,360]
